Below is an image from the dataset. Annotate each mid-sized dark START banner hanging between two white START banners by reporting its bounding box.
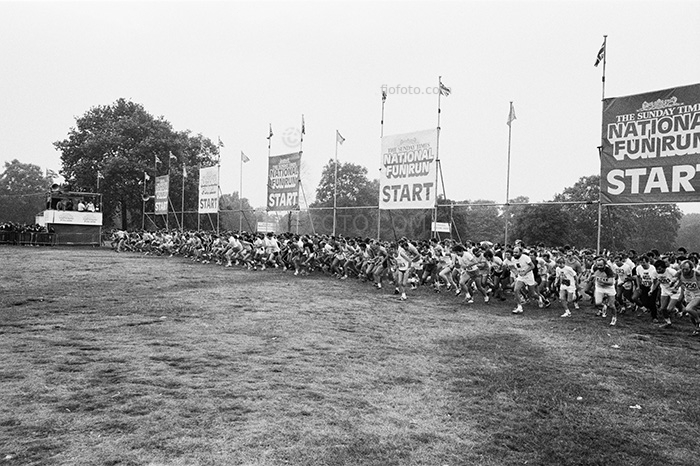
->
[267,152,301,210]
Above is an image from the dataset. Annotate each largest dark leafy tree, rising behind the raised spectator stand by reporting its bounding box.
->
[54,99,218,227]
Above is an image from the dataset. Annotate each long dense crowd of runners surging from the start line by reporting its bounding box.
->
[111,230,700,335]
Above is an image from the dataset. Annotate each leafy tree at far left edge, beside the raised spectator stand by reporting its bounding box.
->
[0,159,51,224]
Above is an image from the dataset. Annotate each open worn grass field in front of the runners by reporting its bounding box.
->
[0,247,700,466]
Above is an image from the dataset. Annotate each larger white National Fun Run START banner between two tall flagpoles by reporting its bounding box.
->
[379,129,437,209]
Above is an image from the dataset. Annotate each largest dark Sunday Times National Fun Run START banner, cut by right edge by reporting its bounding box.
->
[600,84,700,204]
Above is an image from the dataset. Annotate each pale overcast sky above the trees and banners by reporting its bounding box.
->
[0,1,700,212]
